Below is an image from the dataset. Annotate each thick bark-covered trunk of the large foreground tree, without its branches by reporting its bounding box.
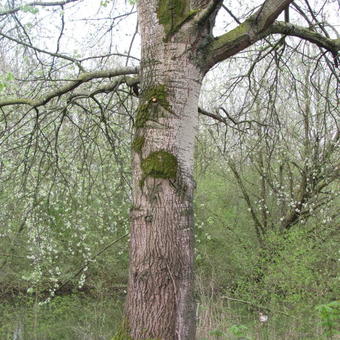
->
[127,0,207,340]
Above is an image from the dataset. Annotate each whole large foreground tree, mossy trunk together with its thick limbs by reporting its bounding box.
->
[0,0,340,340]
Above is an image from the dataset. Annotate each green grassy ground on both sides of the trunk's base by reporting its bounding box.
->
[0,290,339,340]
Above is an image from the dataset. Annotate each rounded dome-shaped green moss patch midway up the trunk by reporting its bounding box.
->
[141,150,178,179]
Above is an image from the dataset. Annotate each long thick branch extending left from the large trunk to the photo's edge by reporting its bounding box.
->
[0,67,139,107]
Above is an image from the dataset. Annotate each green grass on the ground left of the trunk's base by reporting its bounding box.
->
[0,294,123,340]
